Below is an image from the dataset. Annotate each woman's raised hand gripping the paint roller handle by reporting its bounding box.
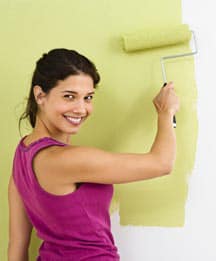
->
[153,82,180,116]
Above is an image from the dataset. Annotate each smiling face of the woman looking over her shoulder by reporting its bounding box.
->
[35,74,94,135]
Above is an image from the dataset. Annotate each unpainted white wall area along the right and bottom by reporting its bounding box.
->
[111,0,216,261]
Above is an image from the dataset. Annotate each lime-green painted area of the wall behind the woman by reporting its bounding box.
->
[0,0,198,260]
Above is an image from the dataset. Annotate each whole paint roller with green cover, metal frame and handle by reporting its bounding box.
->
[122,24,197,128]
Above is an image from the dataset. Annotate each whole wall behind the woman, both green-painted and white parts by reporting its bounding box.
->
[0,0,216,261]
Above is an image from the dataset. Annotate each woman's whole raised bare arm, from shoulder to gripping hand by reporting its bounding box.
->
[34,84,179,184]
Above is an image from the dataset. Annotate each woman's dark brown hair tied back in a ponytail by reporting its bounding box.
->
[19,48,100,129]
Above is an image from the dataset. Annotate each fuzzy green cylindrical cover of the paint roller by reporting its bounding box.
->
[122,24,191,52]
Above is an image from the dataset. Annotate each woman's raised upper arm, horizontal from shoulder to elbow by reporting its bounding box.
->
[41,146,171,184]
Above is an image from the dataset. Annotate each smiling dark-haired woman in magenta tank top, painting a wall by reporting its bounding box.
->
[8,49,179,261]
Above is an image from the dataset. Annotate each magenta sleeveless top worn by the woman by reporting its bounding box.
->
[13,137,120,261]
